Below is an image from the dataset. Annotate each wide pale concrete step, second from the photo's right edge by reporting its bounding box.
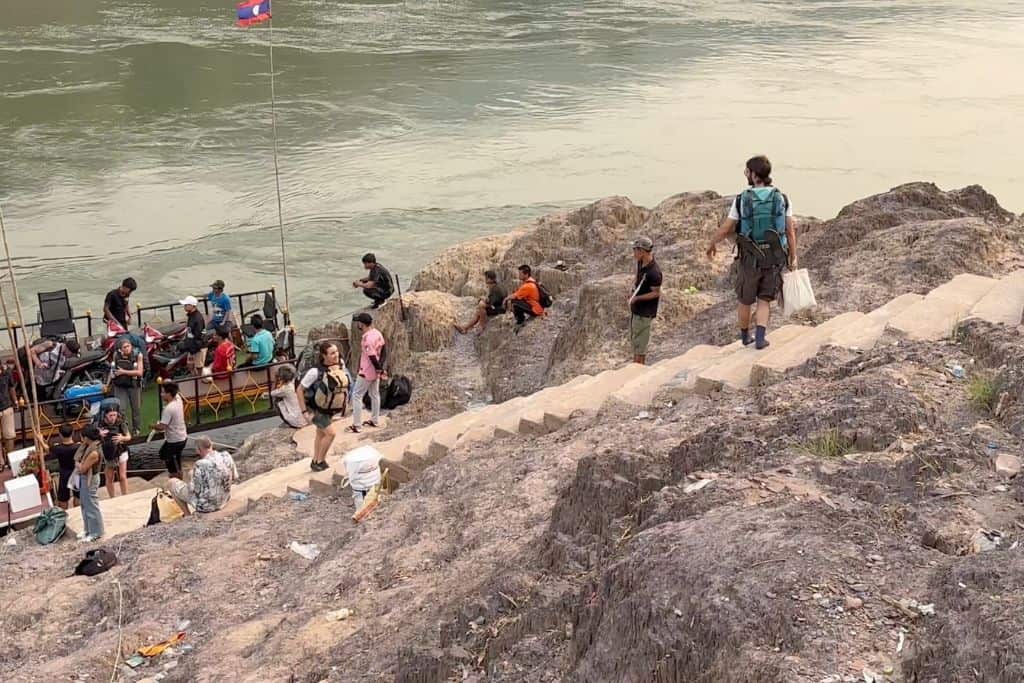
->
[889,273,998,341]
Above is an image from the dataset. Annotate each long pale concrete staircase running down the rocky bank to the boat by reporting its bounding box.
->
[61,270,1024,536]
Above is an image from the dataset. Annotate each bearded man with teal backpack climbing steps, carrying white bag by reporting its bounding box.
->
[708,157,797,349]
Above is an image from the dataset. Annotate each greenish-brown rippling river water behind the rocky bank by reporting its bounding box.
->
[0,0,1024,327]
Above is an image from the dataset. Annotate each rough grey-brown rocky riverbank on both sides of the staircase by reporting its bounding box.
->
[0,183,1024,683]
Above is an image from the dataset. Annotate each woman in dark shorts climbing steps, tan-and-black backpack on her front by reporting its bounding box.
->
[297,341,348,472]
